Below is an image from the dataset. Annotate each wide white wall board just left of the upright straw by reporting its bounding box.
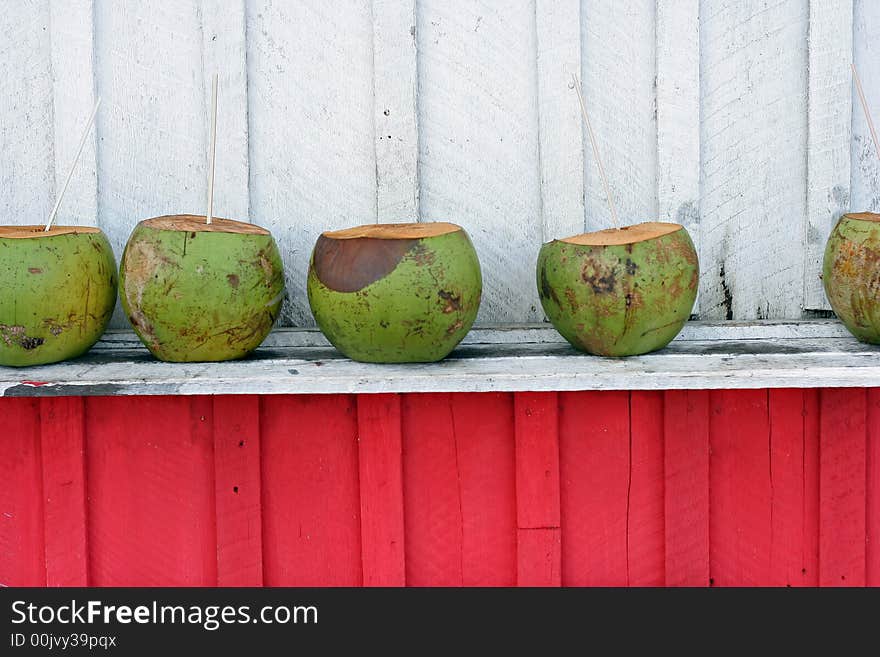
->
[95,0,207,258]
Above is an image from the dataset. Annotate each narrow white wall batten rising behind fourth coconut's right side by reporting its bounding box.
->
[656,0,701,313]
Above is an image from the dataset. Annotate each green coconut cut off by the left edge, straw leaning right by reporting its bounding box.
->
[0,226,116,366]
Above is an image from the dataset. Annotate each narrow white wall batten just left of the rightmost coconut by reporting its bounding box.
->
[804,0,853,309]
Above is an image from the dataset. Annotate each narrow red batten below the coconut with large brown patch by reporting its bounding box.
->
[357,394,406,586]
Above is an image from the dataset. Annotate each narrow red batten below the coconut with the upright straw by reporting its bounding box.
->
[213,395,263,586]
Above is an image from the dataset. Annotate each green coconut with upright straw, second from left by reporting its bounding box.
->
[120,215,284,362]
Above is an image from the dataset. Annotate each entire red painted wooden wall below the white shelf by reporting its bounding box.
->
[0,389,880,586]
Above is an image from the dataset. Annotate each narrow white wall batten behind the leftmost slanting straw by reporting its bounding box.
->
[45,0,98,226]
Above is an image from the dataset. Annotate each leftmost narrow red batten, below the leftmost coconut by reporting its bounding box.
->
[40,397,88,586]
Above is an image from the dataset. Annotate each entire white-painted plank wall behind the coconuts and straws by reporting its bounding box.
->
[0,0,880,325]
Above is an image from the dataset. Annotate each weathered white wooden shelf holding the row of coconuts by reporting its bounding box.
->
[0,320,880,397]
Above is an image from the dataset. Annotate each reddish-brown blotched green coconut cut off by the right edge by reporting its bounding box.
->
[822,212,880,344]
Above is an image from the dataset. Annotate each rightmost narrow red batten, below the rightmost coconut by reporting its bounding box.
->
[819,388,867,586]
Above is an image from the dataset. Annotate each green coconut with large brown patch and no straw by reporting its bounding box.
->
[308,222,483,363]
